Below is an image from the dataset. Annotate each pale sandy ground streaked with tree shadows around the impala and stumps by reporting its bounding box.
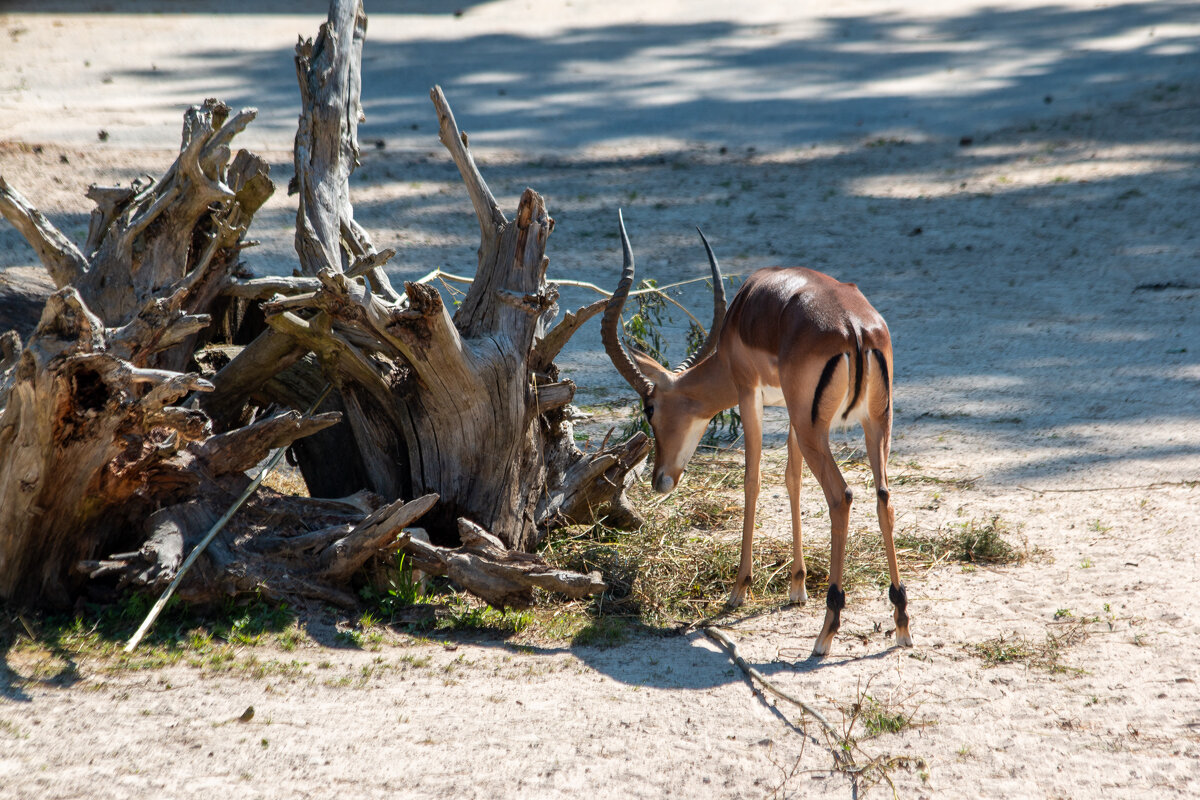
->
[0,0,1200,798]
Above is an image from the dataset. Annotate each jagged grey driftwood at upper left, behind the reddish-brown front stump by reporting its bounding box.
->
[0,100,275,369]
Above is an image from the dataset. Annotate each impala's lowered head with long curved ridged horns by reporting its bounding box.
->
[600,211,725,493]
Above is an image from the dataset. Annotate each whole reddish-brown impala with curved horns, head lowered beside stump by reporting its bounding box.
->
[601,213,912,656]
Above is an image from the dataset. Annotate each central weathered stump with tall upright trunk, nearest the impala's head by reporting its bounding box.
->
[202,0,649,551]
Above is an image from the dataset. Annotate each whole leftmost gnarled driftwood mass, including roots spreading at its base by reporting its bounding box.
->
[0,87,420,606]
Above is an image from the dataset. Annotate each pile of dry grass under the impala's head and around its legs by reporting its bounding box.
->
[534,450,1025,636]
